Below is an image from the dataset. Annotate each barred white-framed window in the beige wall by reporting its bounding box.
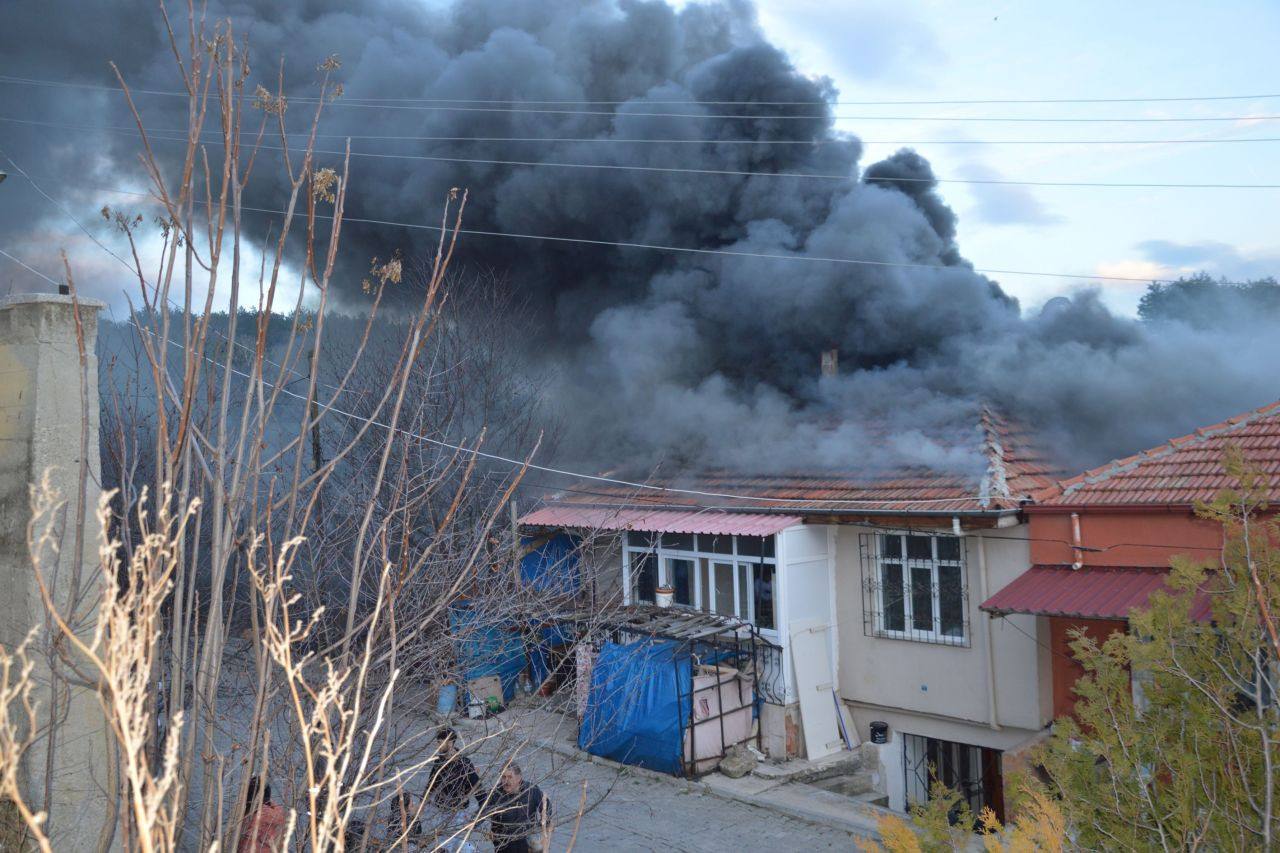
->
[863,533,969,646]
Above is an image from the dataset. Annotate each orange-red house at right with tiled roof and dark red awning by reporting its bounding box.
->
[982,403,1280,717]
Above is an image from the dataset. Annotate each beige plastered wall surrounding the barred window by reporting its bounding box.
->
[836,514,1052,748]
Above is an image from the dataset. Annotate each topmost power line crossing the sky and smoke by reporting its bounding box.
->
[0,74,1280,106]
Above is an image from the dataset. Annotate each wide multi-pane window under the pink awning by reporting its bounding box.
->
[623,533,777,630]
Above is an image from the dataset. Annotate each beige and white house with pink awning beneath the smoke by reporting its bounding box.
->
[521,412,1052,812]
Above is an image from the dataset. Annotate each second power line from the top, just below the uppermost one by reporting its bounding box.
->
[0,77,1280,124]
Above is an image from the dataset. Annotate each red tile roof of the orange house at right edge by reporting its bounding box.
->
[1036,402,1280,506]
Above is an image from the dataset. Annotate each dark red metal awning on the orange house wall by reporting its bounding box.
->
[982,566,1210,621]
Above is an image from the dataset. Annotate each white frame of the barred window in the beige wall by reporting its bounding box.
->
[873,532,969,646]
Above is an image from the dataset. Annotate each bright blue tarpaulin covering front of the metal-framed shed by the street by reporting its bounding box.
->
[577,639,692,775]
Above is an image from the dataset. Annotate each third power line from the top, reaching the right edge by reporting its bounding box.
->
[10,115,1280,146]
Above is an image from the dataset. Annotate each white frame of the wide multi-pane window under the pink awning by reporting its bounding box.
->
[622,530,780,631]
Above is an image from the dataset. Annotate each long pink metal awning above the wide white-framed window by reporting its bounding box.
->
[520,506,800,537]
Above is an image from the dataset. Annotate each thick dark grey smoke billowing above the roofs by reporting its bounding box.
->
[0,0,1280,470]
